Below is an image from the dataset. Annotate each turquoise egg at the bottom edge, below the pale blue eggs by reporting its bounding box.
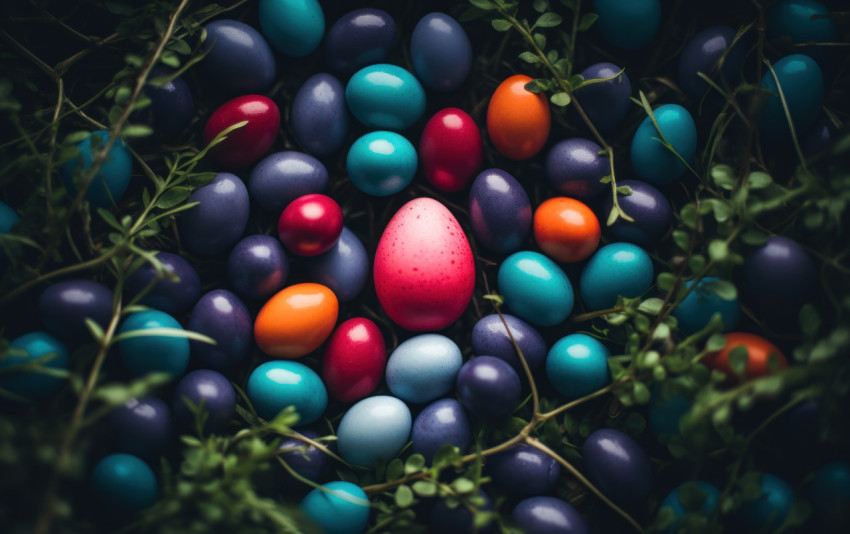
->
[301,480,371,534]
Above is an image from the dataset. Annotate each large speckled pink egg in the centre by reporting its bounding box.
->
[373,197,475,331]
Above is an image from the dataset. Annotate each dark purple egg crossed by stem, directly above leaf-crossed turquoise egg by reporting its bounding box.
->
[124,252,201,315]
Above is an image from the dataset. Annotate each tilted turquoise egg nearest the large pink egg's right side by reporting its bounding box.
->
[498,250,574,326]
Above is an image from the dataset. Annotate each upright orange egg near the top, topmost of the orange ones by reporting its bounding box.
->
[487,74,551,160]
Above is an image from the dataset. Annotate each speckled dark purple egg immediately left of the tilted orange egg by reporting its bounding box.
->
[188,289,254,369]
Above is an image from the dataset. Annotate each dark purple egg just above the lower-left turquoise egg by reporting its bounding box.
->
[106,396,173,458]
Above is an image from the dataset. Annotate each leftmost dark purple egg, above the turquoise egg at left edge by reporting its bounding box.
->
[38,278,112,341]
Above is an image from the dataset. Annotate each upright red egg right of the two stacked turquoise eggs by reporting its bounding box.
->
[419,108,484,193]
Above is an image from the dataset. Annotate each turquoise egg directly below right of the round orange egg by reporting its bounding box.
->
[579,243,655,311]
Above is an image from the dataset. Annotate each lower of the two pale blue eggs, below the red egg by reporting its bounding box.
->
[336,395,413,467]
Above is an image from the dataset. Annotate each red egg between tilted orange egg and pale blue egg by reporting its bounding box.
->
[322,317,387,402]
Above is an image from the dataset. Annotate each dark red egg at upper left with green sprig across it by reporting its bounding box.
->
[204,95,280,169]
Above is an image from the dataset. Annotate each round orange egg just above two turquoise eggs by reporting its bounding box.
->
[534,197,602,263]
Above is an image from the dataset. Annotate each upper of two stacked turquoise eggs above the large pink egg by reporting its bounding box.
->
[345,63,425,130]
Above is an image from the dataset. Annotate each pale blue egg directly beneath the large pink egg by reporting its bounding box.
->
[386,334,463,402]
